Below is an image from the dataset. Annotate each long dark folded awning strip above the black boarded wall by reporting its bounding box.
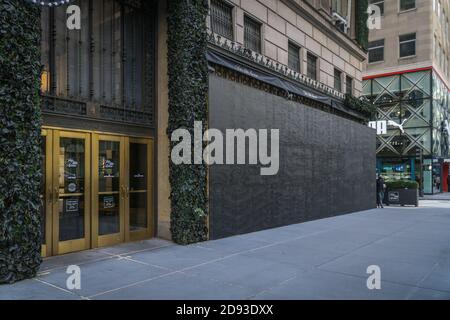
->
[207,50,331,105]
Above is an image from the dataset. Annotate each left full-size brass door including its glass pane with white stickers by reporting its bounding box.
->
[53,132,90,254]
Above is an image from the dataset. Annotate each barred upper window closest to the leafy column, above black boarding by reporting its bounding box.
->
[211,0,233,40]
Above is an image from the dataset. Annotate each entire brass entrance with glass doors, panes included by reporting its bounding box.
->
[41,128,153,257]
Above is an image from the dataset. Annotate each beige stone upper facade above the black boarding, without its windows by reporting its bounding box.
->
[208,0,366,96]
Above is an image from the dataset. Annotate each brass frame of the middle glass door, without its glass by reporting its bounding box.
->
[91,133,127,248]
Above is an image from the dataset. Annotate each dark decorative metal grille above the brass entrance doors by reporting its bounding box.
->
[41,0,155,127]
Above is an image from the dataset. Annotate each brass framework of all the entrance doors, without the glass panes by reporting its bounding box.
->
[41,127,155,257]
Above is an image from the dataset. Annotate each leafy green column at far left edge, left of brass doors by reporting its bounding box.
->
[0,0,41,283]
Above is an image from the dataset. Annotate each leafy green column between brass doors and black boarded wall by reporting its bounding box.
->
[168,0,208,244]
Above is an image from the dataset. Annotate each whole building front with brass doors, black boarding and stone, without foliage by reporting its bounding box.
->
[7,0,375,256]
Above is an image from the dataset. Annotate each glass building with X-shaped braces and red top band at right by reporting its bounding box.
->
[363,68,450,194]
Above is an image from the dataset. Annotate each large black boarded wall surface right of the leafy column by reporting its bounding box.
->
[209,74,376,239]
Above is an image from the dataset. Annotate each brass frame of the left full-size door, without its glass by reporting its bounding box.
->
[52,130,91,255]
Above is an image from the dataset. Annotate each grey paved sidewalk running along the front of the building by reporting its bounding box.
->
[0,200,450,300]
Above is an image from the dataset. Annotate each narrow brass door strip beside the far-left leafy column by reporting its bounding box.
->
[41,129,53,258]
